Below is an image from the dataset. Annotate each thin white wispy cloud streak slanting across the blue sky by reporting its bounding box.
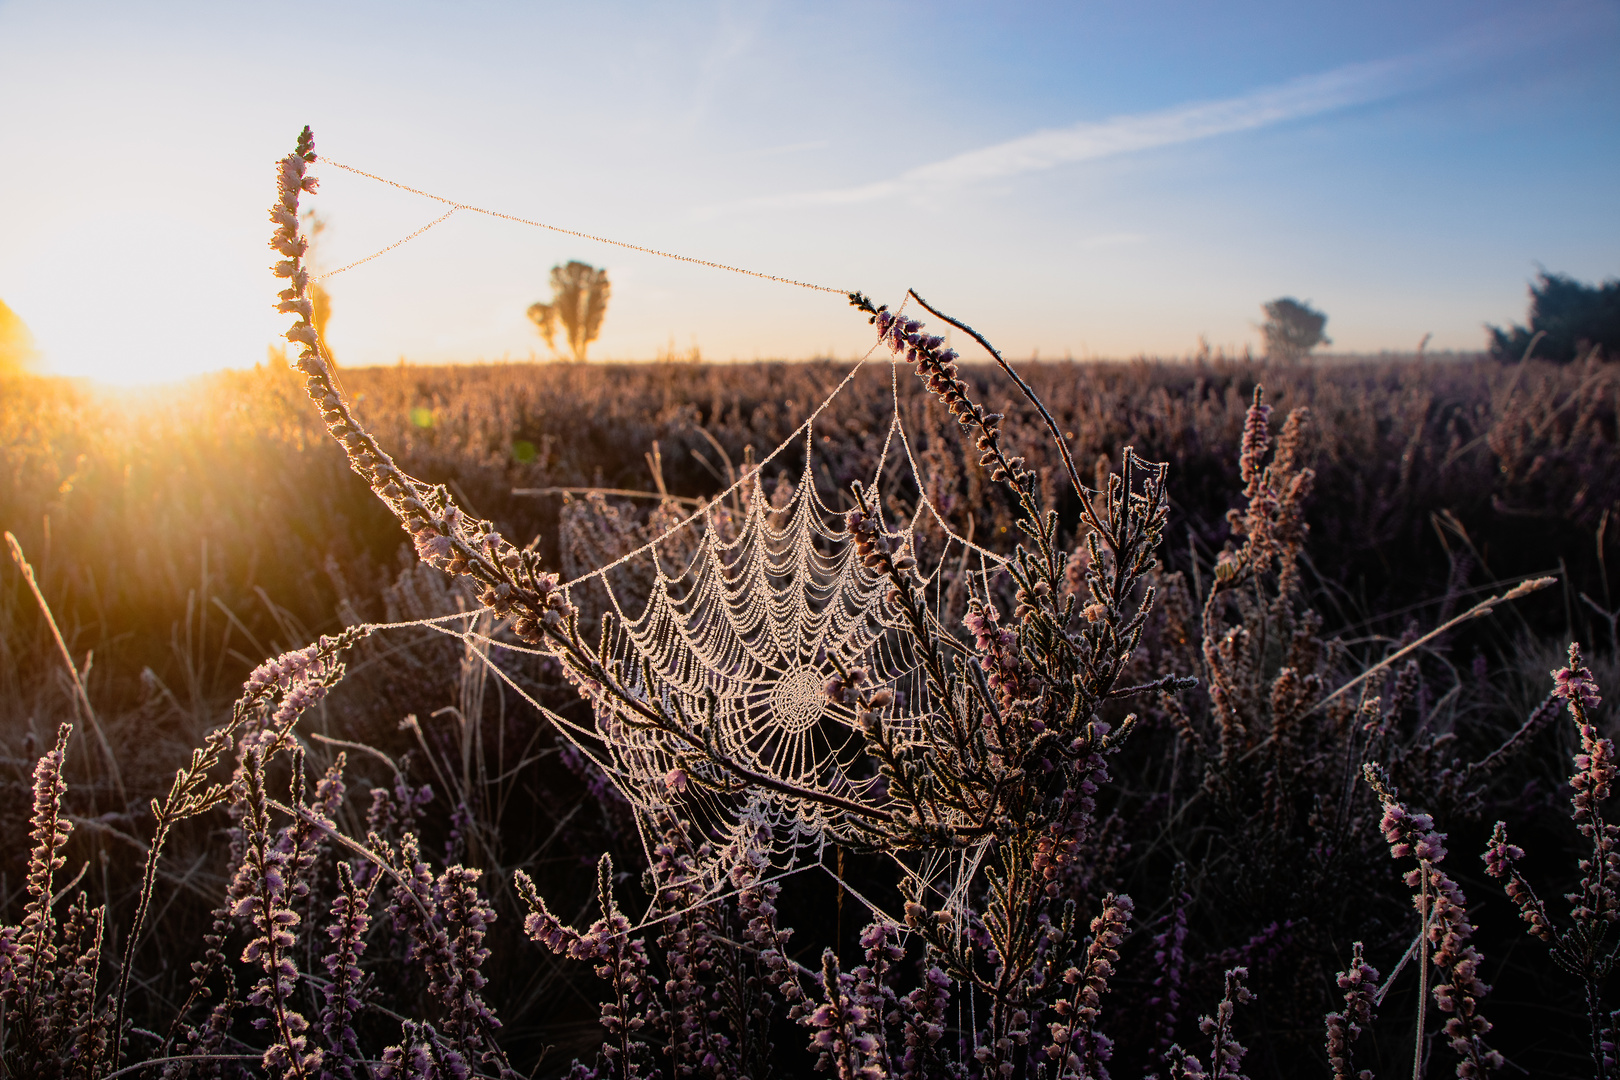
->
[748,37,1503,207]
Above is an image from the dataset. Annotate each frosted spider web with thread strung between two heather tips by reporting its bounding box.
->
[304,159,1004,921]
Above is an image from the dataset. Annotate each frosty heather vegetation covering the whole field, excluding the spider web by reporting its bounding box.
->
[0,137,1620,1077]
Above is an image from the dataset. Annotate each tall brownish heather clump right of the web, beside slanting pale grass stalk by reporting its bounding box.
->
[1153,375,1552,1056]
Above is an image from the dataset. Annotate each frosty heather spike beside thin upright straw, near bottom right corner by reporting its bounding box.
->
[1364,763,1503,1078]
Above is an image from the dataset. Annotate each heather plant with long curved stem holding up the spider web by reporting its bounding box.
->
[262,124,1218,1075]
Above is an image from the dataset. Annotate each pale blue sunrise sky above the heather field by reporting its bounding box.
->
[0,0,1620,381]
